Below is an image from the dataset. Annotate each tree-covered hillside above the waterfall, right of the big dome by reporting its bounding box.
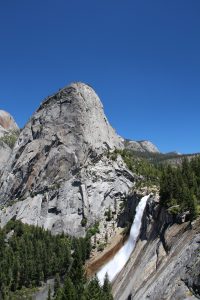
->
[114,150,200,219]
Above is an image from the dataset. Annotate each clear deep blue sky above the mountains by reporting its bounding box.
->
[0,0,200,153]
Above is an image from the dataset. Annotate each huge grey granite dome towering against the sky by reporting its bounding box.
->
[0,83,134,236]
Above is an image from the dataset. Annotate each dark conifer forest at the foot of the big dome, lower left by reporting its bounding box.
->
[0,221,112,300]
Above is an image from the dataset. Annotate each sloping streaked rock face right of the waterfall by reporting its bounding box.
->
[113,201,200,300]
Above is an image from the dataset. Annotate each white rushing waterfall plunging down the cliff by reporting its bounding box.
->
[97,196,149,284]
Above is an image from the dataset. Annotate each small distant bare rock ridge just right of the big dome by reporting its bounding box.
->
[124,140,160,153]
